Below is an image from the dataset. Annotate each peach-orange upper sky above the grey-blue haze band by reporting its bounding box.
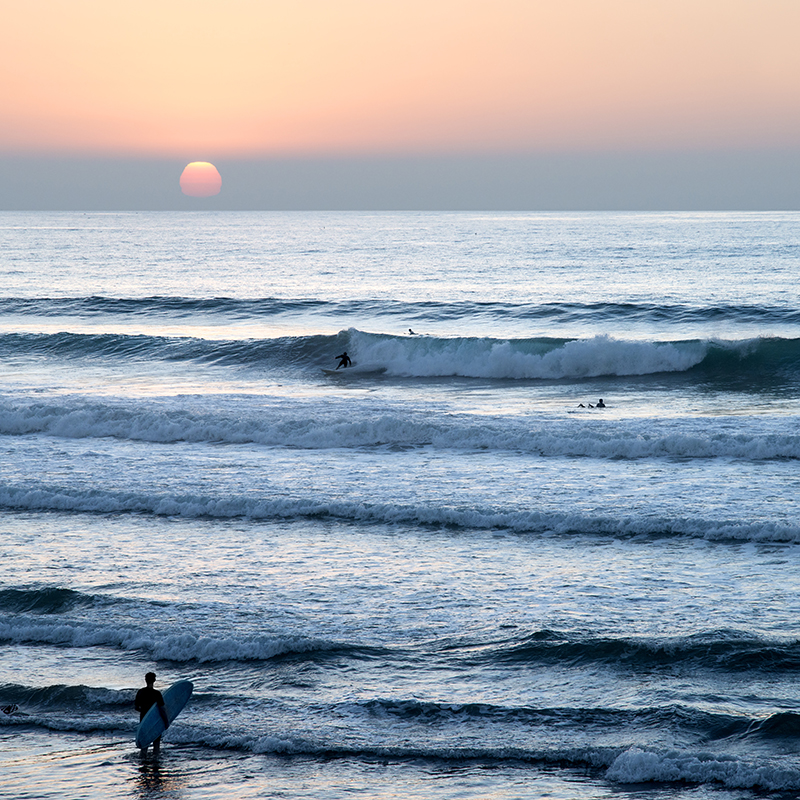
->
[0,0,800,157]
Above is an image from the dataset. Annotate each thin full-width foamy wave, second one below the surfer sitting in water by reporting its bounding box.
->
[0,484,800,543]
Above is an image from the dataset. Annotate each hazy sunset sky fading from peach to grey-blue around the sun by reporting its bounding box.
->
[0,0,800,210]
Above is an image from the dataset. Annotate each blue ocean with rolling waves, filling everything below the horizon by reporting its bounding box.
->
[0,212,800,800]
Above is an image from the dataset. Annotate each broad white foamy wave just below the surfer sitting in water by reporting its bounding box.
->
[0,396,800,461]
